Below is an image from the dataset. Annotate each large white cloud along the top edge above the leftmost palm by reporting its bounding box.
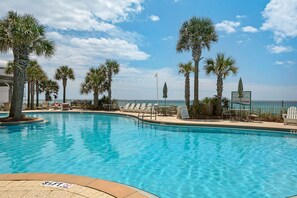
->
[0,0,143,31]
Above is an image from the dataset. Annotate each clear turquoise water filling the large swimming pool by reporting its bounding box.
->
[0,113,297,198]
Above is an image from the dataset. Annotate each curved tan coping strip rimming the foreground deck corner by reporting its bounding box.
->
[0,173,157,198]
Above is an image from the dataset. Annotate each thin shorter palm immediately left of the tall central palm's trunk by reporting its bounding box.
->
[178,61,194,110]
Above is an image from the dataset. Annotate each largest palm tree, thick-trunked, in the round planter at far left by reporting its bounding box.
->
[0,11,54,120]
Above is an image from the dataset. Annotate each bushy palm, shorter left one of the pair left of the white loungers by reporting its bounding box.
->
[80,66,108,108]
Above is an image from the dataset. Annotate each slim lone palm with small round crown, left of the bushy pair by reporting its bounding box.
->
[55,65,75,103]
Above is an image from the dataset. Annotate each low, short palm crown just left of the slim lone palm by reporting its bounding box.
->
[39,80,59,101]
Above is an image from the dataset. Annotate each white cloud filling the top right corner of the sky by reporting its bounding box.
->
[261,0,297,43]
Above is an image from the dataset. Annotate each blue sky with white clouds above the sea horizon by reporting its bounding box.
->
[0,0,297,101]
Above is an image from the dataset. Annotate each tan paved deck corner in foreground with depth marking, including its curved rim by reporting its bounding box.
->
[0,173,156,198]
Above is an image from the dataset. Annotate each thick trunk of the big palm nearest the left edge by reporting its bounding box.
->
[9,48,29,120]
